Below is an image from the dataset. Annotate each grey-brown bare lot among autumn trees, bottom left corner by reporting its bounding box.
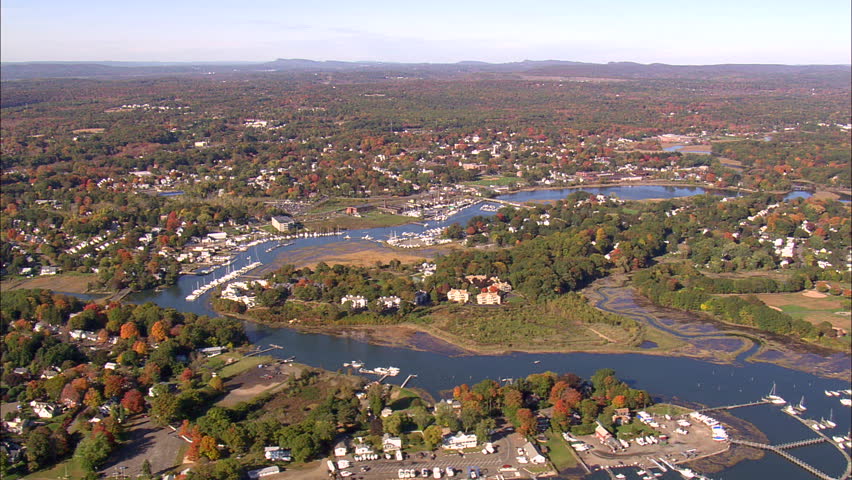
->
[103,417,189,478]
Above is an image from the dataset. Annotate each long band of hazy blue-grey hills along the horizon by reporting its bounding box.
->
[0,59,852,81]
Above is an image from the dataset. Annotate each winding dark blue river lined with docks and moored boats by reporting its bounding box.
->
[127,186,852,480]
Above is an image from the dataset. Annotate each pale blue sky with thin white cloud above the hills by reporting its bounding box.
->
[0,0,852,65]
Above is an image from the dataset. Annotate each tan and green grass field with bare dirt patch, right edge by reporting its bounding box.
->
[756,291,852,332]
